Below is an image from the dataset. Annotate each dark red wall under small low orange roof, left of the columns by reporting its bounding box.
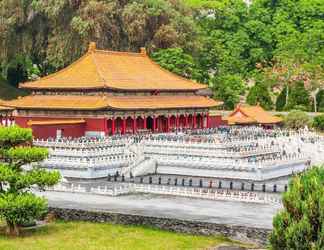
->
[32,124,85,139]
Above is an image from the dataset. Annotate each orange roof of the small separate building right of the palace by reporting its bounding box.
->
[225,105,282,124]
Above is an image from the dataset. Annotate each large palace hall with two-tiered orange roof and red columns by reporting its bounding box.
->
[0,43,222,139]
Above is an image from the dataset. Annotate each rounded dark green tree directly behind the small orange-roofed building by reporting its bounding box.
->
[246,83,273,110]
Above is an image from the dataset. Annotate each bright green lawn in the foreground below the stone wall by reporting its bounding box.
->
[0,222,244,250]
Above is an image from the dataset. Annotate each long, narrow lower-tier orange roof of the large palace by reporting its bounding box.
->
[6,95,222,110]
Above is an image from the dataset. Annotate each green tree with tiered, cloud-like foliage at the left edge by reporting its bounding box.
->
[0,127,60,235]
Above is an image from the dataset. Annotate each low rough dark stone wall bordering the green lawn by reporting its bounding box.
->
[49,207,270,246]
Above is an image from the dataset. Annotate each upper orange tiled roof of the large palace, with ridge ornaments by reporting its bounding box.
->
[20,43,207,91]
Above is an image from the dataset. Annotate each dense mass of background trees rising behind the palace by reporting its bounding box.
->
[0,0,324,110]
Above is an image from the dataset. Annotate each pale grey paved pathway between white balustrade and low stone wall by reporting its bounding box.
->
[38,192,281,228]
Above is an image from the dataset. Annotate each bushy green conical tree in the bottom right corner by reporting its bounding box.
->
[270,166,324,250]
